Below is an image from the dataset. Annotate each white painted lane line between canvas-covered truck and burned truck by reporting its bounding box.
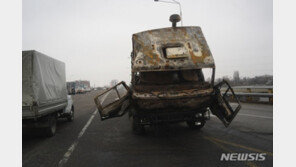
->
[58,110,98,167]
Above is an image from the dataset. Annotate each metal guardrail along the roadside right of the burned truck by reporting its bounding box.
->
[221,86,273,104]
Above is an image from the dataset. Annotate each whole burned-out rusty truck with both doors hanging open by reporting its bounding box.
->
[94,15,241,134]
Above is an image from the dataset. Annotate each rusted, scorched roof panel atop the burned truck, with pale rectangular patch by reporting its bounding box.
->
[132,27,215,72]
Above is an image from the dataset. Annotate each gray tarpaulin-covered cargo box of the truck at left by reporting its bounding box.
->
[22,50,67,119]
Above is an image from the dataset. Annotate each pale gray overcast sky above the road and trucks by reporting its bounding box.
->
[22,0,273,86]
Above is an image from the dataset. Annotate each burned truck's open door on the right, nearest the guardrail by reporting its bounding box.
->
[210,80,241,127]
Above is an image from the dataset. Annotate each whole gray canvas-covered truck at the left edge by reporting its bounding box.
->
[22,50,74,136]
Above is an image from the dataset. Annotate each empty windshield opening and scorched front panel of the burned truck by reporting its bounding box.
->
[131,69,214,110]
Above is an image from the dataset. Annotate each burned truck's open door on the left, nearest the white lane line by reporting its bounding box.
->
[94,81,131,120]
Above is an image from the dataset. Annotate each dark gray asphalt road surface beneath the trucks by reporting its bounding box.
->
[22,91,273,167]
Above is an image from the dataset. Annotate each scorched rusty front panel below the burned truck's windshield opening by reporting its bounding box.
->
[132,85,214,111]
